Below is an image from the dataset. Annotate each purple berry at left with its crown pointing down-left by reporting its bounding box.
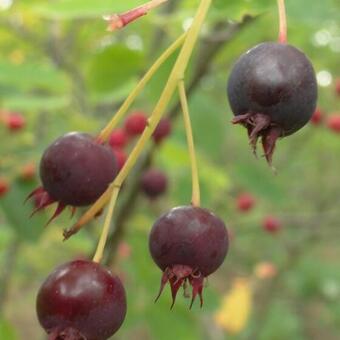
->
[29,132,117,223]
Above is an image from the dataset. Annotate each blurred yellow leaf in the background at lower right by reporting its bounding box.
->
[215,278,252,334]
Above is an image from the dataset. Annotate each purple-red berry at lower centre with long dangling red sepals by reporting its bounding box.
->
[149,206,228,308]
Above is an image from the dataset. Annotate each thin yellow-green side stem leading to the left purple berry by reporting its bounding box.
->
[99,33,186,142]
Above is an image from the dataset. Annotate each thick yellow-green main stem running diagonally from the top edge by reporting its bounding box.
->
[64,0,212,238]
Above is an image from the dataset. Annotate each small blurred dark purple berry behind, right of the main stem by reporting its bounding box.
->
[141,169,168,199]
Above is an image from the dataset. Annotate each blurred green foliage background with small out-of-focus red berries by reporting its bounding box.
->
[0,0,340,340]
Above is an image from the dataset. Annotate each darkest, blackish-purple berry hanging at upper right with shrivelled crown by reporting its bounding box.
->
[228,42,317,164]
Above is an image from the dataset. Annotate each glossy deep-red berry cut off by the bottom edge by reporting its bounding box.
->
[36,260,126,340]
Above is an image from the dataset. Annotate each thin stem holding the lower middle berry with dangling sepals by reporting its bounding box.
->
[178,80,201,207]
